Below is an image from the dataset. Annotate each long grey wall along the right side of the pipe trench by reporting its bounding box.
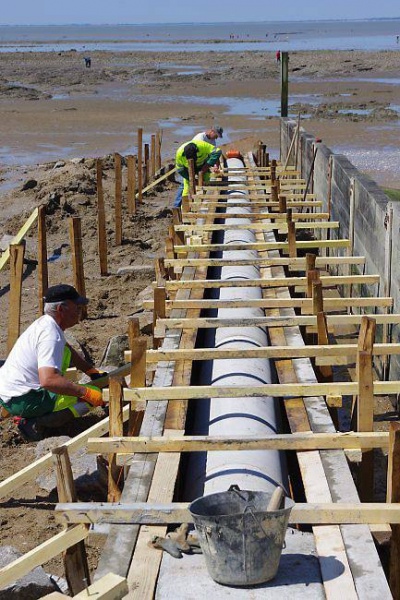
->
[281,119,400,379]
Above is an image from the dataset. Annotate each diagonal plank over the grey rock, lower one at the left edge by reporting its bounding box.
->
[0,524,89,588]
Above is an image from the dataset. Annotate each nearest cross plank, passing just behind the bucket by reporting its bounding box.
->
[55,502,400,525]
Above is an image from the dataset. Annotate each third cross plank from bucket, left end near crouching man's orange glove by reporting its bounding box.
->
[120,381,400,402]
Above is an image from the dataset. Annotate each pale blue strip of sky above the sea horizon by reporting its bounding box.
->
[0,0,400,25]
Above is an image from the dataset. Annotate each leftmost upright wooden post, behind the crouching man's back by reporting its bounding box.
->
[7,244,25,354]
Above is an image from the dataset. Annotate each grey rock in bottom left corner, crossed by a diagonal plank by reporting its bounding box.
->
[0,546,57,600]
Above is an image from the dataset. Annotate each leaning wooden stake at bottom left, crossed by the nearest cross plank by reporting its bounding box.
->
[52,446,90,596]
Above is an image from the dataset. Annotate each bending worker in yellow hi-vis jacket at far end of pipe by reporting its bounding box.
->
[174,140,222,208]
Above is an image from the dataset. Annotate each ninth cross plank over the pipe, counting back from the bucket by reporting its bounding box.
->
[174,239,349,254]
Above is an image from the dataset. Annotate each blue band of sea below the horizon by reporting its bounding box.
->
[0,18,400,52]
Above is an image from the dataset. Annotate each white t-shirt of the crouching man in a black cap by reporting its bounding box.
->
[0,315,66,402]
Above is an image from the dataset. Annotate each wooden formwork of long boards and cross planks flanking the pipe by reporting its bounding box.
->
[0,158,400,599]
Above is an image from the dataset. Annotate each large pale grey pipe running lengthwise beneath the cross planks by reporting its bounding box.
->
[204,159,287,494]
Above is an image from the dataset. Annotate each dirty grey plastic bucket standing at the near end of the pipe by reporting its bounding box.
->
[189,486,294,586]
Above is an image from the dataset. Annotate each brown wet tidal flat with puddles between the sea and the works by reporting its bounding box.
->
[0,51,400,187]
